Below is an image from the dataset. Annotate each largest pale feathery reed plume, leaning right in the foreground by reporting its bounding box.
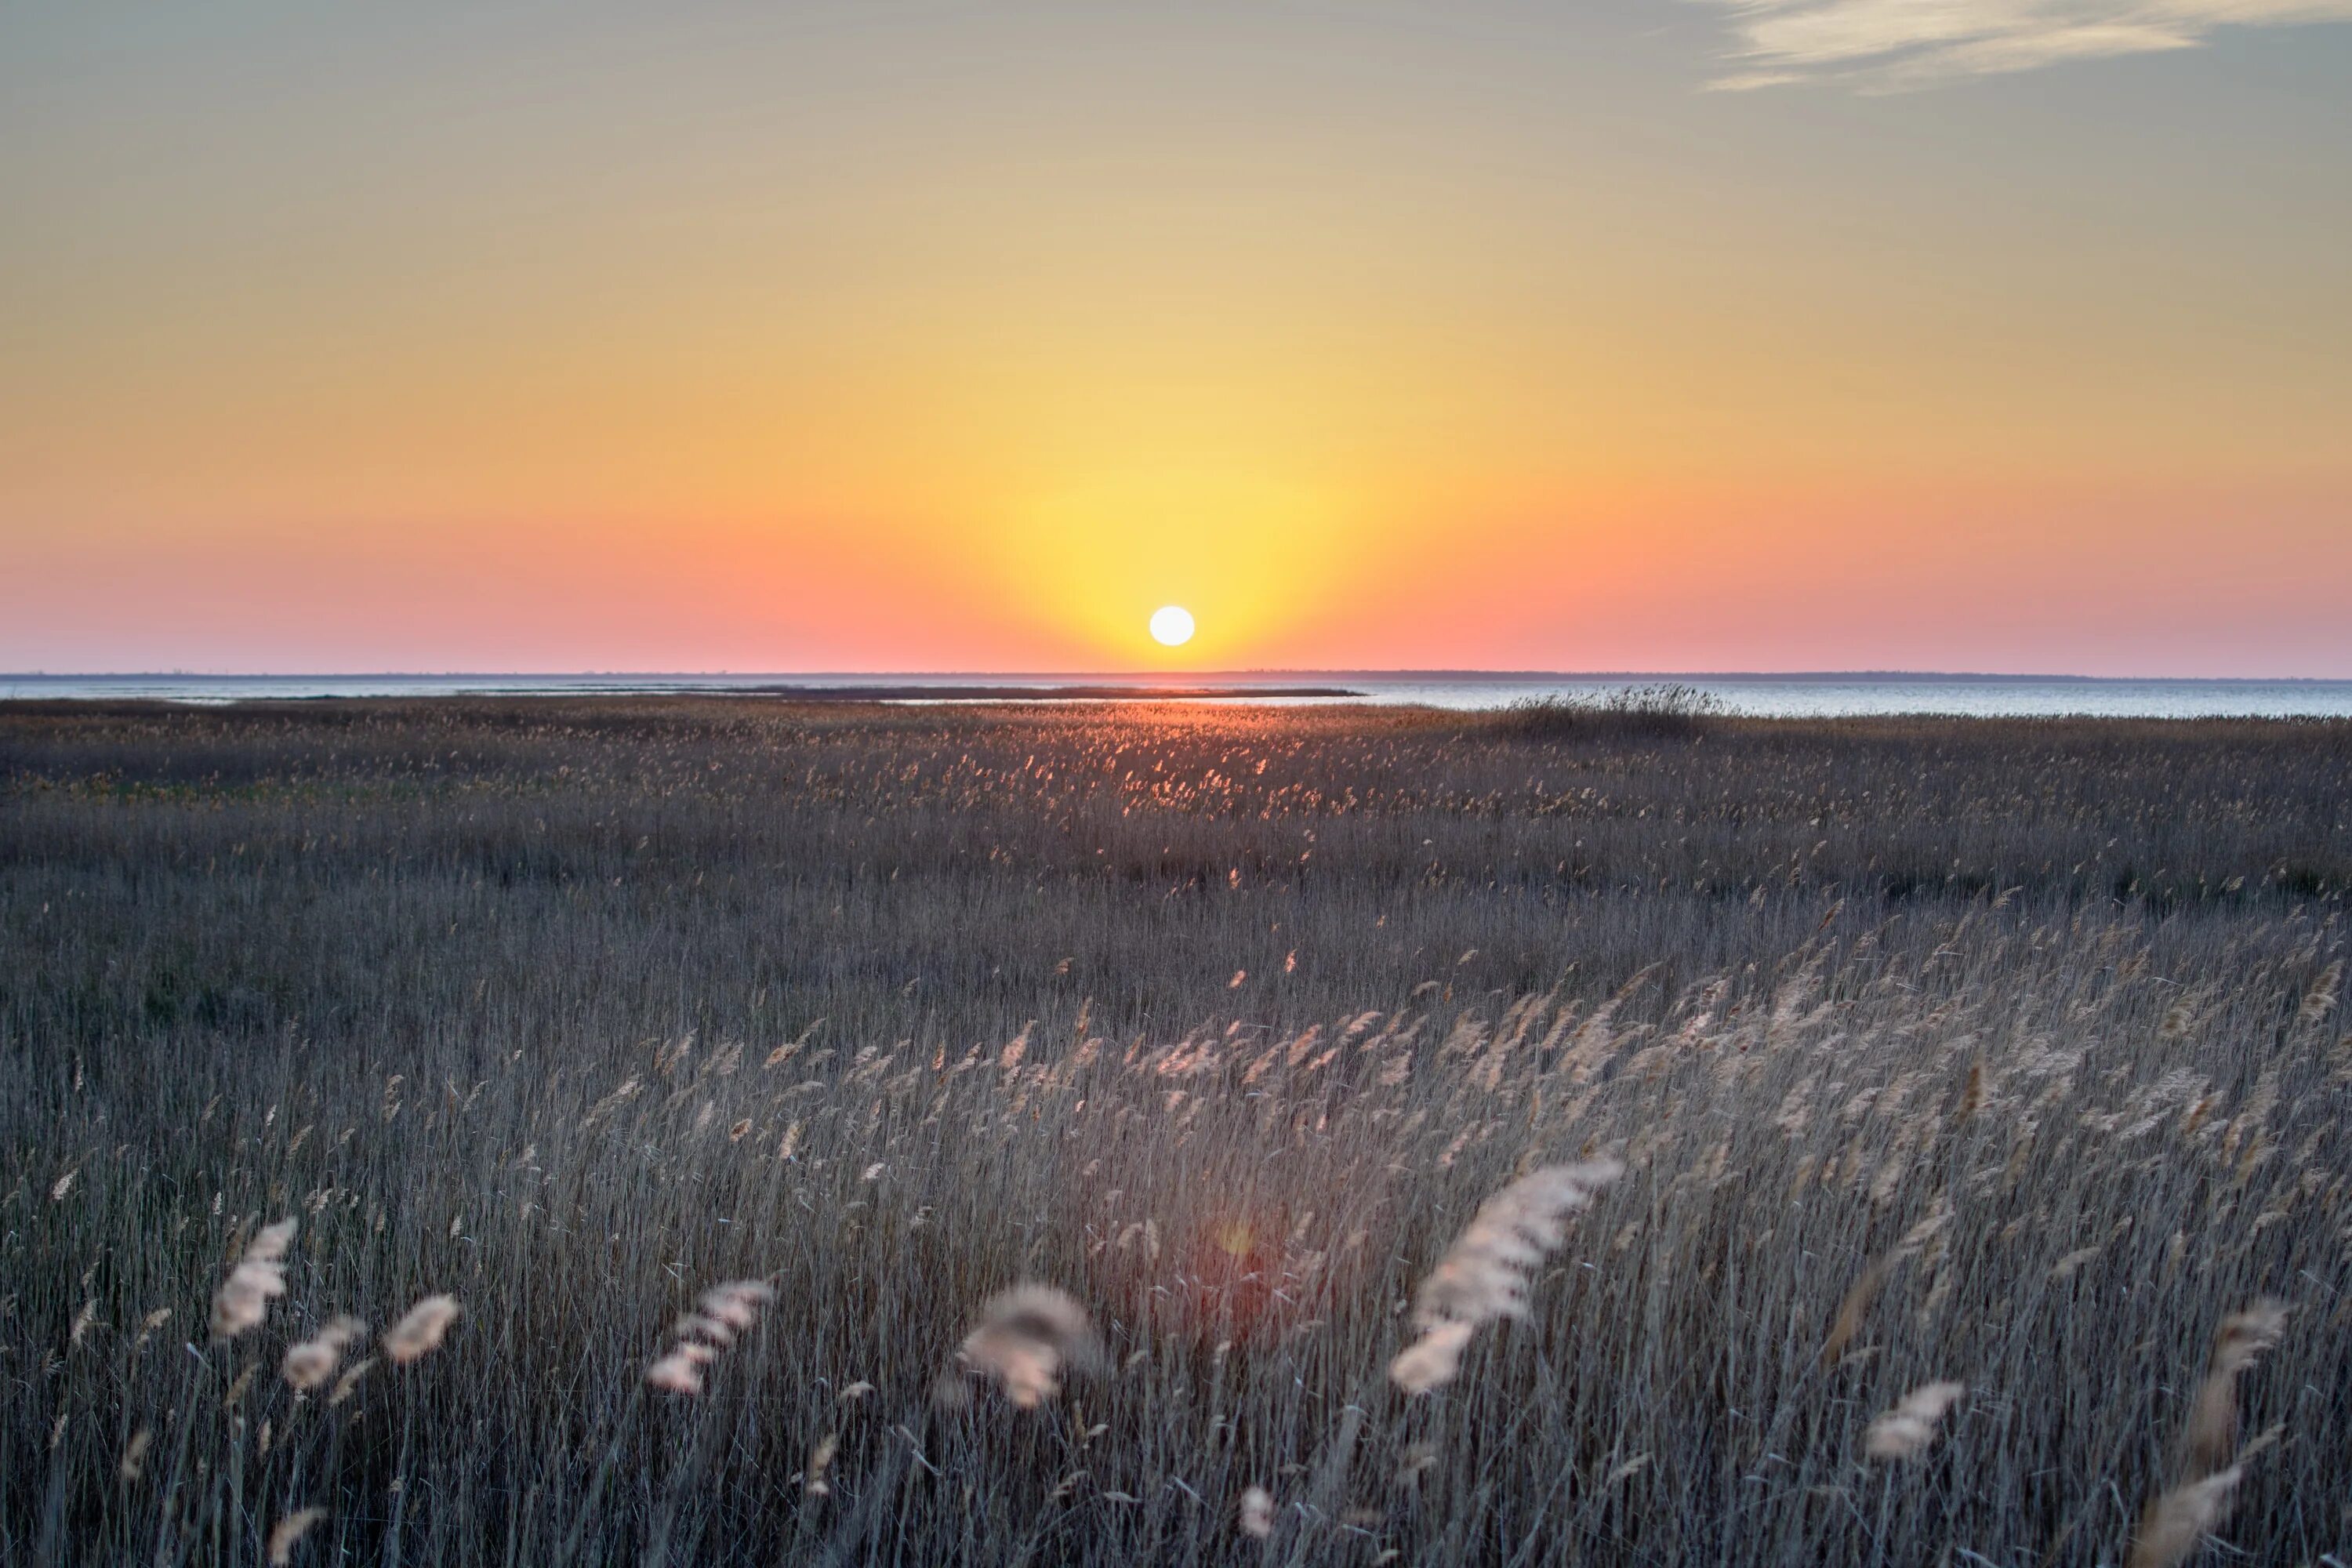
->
[1388,1159,1625,1394]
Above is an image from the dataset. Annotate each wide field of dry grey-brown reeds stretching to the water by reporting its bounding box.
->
[0,699,2352,1568]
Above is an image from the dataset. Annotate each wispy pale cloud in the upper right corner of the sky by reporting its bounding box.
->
[1700,0,2352,92]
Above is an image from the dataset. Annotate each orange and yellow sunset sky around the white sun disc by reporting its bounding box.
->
[0,0,2352,677]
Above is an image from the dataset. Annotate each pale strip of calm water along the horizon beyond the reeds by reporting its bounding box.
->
[0,670,2352,720]
